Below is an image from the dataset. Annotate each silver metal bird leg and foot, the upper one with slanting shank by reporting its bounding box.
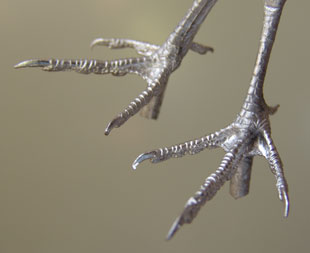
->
[15,0,216,135]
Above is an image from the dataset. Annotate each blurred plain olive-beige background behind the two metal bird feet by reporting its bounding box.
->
[0,0,310,253]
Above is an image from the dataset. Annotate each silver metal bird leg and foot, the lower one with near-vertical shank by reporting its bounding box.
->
[132,0,289,239]
